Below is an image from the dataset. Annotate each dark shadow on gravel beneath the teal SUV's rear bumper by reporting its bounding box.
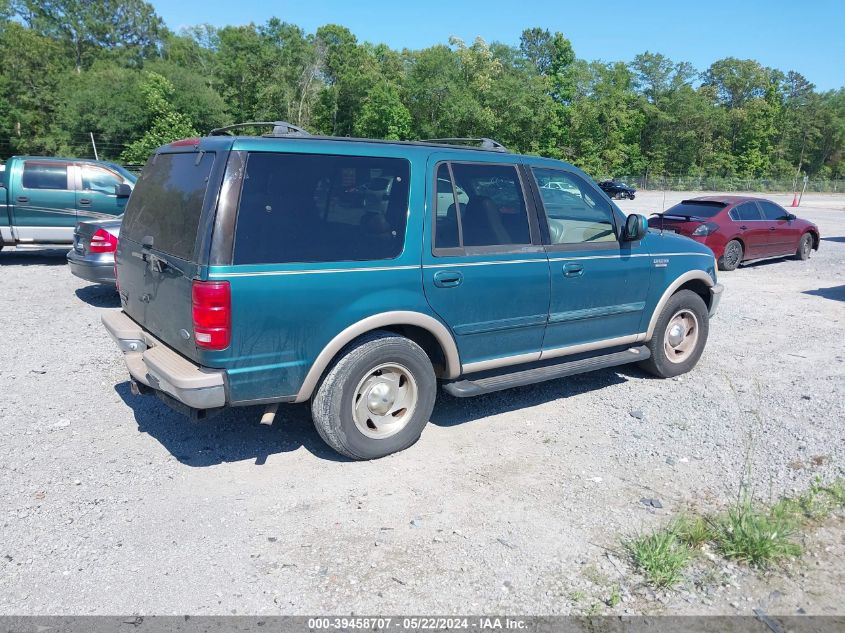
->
[115,382,350,468]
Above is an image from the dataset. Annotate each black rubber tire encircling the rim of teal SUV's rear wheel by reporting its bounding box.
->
[311,330,437,459]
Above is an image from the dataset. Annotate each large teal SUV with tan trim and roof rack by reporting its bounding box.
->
[103,123,722,459]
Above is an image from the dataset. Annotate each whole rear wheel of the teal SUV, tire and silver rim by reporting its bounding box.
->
[311,330,437,459]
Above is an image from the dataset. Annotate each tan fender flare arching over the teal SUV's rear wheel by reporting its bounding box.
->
[294,310,461,402]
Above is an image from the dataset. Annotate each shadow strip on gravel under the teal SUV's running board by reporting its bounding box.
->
[431,366,632,427]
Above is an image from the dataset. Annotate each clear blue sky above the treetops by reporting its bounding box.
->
[152,0,845,90]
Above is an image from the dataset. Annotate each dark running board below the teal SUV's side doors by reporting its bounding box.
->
[443,345,651,398]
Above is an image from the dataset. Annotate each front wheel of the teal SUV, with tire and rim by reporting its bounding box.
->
[639,290,710,378]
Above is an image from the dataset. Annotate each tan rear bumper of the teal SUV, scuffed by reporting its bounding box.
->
[102,312,226,409]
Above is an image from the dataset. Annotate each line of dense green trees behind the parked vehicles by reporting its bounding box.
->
[0,0,845,185]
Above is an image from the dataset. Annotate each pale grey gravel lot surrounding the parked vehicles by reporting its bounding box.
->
[0,192,845,614]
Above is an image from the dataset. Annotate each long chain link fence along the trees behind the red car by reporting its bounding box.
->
[615,174,845,193]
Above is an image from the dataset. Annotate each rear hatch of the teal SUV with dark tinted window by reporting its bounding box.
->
[117,148,222,360]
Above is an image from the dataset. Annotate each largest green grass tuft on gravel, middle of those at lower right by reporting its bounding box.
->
[714,497,801,567]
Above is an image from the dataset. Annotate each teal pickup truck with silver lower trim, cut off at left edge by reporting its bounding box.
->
[0,156,136,248]
